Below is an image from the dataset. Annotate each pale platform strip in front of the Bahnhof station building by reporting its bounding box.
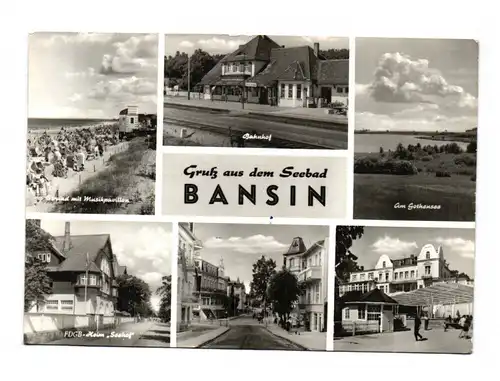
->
[164,96,347,126]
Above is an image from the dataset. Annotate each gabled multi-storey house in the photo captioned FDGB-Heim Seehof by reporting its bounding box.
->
[30,222,119,317]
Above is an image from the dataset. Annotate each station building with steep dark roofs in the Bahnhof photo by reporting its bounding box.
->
[198,35,349,107]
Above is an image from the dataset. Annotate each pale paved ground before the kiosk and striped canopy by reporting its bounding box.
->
[333,329,472,353]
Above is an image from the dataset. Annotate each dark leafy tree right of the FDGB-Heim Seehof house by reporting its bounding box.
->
[116,274,151,316]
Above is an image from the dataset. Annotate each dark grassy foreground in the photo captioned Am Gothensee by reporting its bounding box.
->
[354,173,476,221]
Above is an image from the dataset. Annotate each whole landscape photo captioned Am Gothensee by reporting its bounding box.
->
[354,38,478,221]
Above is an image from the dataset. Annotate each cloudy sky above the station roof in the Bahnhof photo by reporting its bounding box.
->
[165,34,349,56]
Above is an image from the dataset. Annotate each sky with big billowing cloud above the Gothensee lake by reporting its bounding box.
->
[355,38,478,131]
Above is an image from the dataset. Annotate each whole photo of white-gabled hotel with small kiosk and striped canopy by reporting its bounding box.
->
[334,226,475,354]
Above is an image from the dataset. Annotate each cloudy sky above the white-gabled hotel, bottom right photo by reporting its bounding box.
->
[351,227,475,278]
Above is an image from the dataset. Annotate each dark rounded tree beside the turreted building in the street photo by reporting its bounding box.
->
[267,268,302,321]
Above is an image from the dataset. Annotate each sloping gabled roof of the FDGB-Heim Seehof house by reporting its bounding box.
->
[54,234,109,272]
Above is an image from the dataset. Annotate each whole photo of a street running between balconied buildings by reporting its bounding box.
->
[177,222,329,351]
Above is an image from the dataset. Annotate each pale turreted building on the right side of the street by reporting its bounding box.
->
[284,237,328,331]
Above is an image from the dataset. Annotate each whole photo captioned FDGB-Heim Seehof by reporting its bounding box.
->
[24,219,172,347]
